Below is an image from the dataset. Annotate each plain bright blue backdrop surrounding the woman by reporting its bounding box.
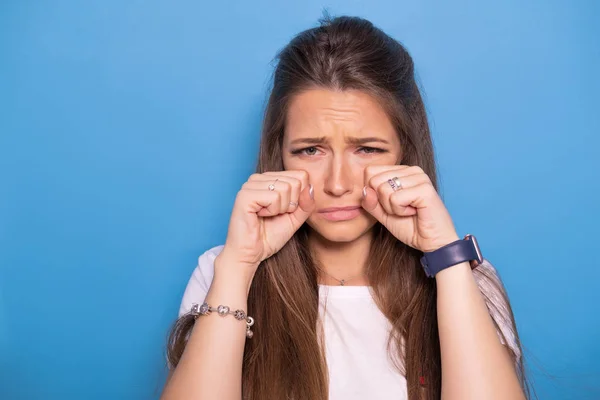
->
[0,0,600,400]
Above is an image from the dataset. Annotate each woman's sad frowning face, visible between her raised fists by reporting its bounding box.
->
[283,89,401,242]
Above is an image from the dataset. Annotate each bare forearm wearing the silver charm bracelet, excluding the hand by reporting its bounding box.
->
[161,255,252,400]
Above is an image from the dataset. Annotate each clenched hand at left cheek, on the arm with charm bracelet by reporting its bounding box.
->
[221,170,315,275]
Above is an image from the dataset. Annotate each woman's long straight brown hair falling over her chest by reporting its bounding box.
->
[168,16,529,400]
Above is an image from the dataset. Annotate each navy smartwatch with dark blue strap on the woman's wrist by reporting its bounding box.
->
[421,234,483,278]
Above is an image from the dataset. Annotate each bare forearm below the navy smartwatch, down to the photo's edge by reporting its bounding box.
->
[436,262,525,400]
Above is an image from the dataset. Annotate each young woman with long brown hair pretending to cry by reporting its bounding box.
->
[162,17,528,400]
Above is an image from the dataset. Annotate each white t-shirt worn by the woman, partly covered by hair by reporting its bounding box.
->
[179,245,516,400]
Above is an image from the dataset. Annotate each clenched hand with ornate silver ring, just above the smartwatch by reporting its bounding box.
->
[362,165,459,252]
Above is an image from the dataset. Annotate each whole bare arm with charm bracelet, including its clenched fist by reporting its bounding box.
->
[161,170,315,400]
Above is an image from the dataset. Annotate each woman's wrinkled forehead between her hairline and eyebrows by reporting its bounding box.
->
[286,89,396,139]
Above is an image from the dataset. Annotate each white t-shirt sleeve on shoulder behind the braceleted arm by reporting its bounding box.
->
[179,245,223,317]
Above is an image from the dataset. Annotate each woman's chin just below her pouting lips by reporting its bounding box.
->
[306,216,376,243]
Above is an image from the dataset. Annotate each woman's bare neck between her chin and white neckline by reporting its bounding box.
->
[308,231,372,286]
